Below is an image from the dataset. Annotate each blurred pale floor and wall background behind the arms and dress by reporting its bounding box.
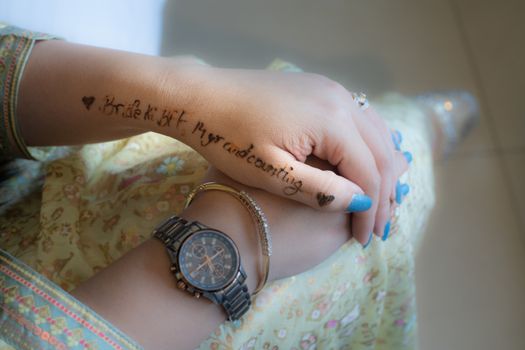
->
[0,0,525,350]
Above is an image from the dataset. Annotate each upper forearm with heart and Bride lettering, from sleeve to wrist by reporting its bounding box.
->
[17,41,205,146]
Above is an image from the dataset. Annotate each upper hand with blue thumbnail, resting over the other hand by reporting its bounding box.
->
[168,65,406,244]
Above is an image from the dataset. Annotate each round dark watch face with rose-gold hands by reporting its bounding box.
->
[178,230,240,291]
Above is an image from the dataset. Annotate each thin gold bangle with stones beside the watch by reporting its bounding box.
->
[184,182,272,295]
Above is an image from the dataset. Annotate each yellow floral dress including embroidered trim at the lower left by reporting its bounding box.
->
[0,23,434,349]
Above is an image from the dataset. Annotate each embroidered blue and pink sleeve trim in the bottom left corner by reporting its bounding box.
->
[0,250,141,349]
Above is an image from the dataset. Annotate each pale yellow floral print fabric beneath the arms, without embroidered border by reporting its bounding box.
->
[0,96,434,349]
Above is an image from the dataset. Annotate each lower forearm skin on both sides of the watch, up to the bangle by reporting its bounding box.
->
[68,180,266,349]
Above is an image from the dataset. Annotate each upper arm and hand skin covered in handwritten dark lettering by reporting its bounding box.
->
[17,41,406,244]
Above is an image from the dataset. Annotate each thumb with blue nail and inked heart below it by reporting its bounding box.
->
[267,159,372,212]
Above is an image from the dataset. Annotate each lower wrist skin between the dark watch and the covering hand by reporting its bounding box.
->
[194,167,350,282]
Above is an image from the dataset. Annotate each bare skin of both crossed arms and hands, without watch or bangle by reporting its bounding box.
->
[17,41,412,349]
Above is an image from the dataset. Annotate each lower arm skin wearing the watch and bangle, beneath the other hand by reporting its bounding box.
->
[72,160,348,349]
